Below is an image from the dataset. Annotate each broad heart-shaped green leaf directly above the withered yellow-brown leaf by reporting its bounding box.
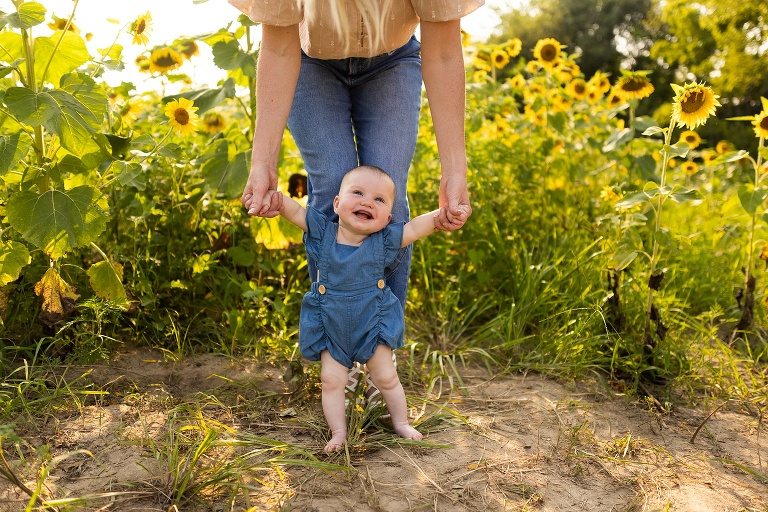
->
[6,185,107,259]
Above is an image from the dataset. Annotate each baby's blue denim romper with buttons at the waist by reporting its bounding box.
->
[299,207,405,368]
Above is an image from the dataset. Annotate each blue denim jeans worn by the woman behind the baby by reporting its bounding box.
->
[288,37,421,308]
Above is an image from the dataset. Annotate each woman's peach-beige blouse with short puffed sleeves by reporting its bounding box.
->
[229,0,485,59]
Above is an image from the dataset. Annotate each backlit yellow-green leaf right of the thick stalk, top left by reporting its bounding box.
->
[35,31,91,85]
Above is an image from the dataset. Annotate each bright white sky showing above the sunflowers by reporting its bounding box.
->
[0,0,520,89]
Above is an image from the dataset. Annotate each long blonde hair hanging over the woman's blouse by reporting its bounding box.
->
[302,0,393,55]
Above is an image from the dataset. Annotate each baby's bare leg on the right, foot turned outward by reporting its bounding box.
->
[365,345,423,440]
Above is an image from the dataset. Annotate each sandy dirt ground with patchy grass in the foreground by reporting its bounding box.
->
[0,349,768,512]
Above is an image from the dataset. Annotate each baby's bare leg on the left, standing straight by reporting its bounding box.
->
[320,350,347,452]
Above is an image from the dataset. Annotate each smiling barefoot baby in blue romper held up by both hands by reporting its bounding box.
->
[273,165,469,452]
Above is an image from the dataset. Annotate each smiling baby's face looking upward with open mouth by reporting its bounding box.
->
[333,168,395,235]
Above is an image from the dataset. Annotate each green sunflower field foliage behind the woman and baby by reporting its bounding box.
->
[0,1,768,400]
